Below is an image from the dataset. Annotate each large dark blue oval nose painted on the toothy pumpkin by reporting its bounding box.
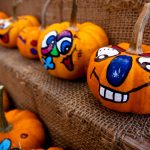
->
[107,55,132,87]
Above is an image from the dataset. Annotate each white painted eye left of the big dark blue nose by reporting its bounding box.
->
[95,47,120,62]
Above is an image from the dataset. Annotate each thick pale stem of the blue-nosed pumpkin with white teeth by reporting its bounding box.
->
[127,3,150,54]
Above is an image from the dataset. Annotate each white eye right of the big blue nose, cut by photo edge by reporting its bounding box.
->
[137,57,150,72]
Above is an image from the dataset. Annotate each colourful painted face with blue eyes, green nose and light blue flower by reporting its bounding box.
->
[41,30,74,71]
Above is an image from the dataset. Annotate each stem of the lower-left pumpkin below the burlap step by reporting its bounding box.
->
[0,85,12,132]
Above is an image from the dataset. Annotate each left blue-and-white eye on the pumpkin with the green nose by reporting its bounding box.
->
[42,31,57,48]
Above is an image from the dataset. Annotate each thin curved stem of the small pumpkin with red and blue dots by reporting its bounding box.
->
[41,0,51,29]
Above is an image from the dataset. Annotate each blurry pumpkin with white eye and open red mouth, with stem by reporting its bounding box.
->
[0,0,39,47]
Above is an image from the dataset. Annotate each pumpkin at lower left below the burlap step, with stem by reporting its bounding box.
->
[0,86,45,149]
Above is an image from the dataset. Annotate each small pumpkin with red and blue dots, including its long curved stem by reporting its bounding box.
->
[17,0,51,59]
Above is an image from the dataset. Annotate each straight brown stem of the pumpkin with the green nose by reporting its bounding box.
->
[69,0,78,31]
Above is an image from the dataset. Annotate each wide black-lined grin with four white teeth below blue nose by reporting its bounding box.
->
[90,68,150,103]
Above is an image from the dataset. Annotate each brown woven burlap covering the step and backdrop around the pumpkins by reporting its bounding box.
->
[0,0,150,150]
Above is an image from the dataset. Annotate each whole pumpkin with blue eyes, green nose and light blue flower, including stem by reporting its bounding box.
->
[38,0,108,79]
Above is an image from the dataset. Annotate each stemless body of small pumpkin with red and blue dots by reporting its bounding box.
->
[17,26,41,58]
